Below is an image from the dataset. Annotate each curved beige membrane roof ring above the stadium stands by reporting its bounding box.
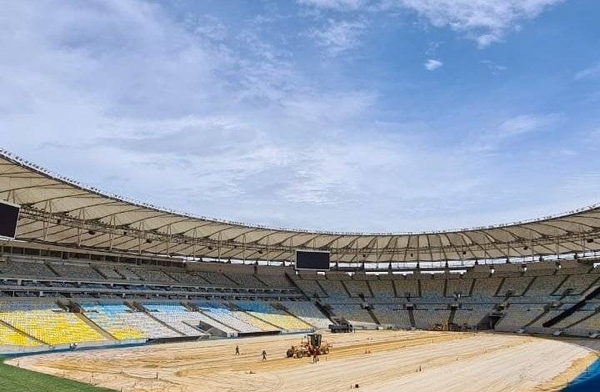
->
[0,151,600,263]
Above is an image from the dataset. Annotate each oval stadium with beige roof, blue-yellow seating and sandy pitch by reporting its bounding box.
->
[0,152,600,391]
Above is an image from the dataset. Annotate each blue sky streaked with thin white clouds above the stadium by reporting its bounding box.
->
[0,0,600,232]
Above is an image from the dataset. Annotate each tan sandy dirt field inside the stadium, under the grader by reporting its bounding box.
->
[8,331,597,392]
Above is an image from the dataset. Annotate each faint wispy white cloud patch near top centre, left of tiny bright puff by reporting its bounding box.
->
[309,19,367,56]
